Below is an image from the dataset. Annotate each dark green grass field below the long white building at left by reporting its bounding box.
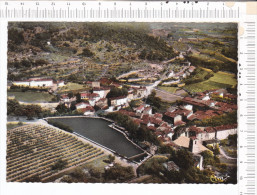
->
[7,91,54,103]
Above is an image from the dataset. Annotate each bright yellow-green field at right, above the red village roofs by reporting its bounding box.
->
[184,72,237,93]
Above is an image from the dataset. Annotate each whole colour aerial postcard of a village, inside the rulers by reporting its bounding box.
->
[6,22,238,185]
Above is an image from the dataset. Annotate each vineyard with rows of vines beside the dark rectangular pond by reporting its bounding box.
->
[7,125,103,182]
